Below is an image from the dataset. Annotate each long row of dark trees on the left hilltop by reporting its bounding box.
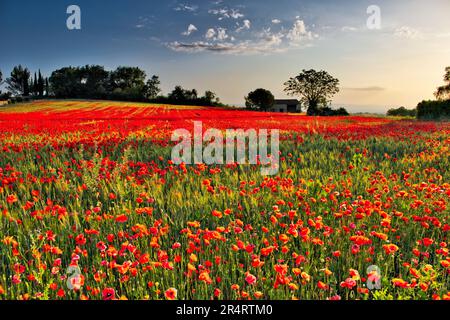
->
[0,65,222,106]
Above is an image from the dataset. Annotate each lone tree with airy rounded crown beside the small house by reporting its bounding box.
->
[284,69,339,115]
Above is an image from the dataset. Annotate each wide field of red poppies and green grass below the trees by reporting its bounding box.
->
[0,101,450,300]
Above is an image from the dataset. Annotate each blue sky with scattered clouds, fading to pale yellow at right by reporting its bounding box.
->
[0,0,450,112]
